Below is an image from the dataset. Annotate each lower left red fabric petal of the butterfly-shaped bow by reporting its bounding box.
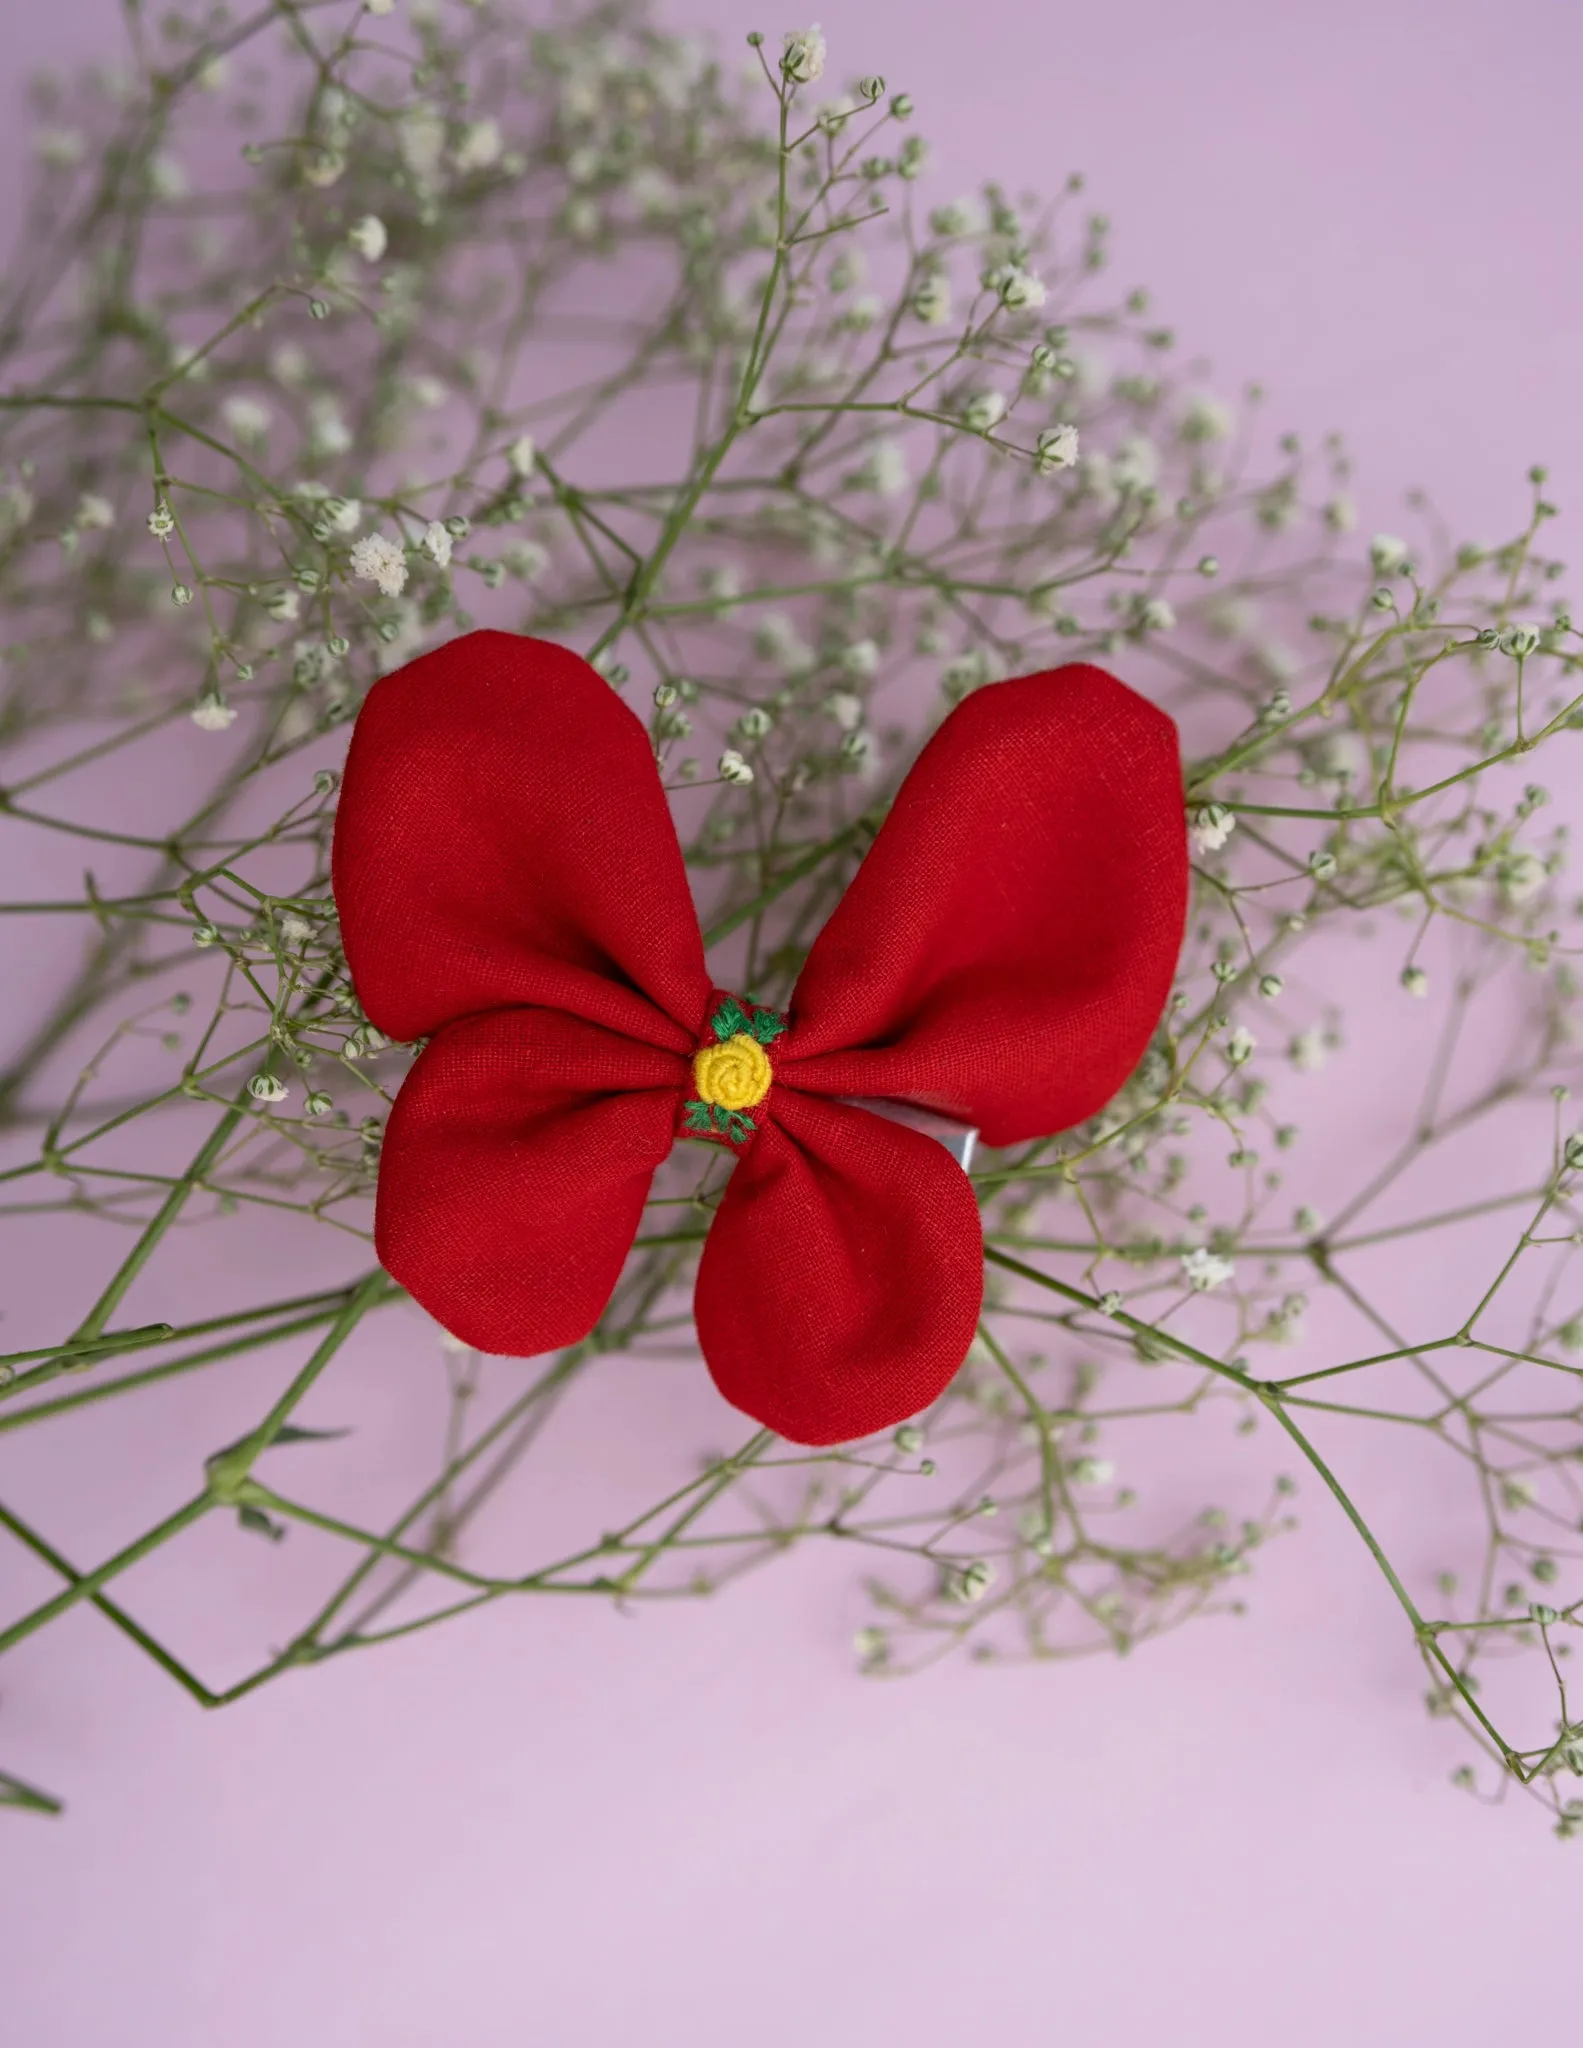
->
[375,1010,688,1358]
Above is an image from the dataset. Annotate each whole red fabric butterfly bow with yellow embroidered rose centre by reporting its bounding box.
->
[334,633,1188,1444]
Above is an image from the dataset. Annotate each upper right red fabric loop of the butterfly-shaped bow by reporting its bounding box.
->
[784,664,1188,1145]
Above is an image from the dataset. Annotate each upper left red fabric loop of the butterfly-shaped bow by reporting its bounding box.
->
[334,633,711,1053]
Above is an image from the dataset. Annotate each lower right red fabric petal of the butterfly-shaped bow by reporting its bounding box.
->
[694,1090,983,1444]
